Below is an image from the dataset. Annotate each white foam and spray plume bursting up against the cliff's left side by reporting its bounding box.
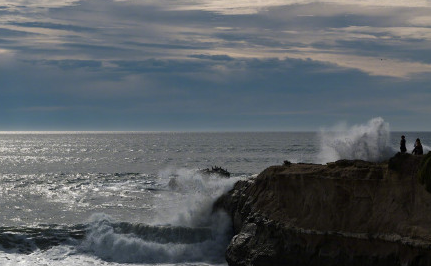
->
[80,169,238,264]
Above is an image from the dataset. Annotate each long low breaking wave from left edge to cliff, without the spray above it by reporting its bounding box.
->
[0,214,228,263]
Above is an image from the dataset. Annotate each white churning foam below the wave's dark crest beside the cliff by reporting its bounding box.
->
[80,214,229,264]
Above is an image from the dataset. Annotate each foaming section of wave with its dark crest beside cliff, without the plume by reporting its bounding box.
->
[79,213,230,264]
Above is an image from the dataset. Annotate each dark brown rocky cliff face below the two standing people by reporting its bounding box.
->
[215,154,431,266]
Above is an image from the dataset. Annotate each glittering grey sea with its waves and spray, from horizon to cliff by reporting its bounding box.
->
[0,119,431,266]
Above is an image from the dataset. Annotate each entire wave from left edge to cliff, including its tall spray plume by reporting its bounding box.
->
[0,169,243,264]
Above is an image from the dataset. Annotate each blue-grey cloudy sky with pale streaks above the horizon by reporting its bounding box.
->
[0,0,431,131]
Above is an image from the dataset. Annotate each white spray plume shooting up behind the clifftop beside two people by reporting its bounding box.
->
[318,117,395,163]
